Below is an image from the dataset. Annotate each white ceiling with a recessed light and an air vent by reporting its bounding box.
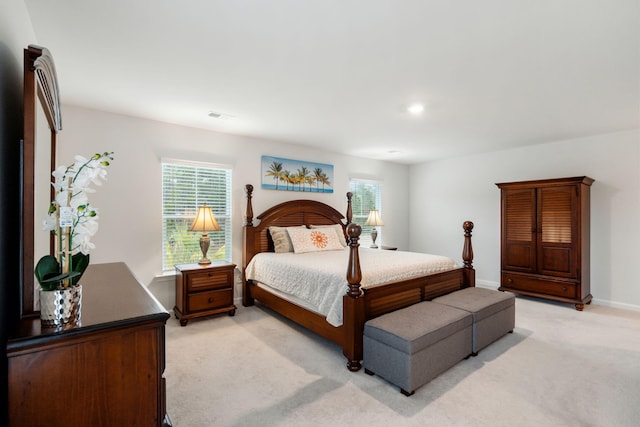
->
[25,0,640,164]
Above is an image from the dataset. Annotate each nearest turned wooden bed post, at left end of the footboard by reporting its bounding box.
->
[342,222,365,372]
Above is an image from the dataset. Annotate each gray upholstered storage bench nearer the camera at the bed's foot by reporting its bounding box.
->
[363,301,473,396]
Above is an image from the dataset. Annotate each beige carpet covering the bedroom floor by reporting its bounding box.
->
[165,297,640,427]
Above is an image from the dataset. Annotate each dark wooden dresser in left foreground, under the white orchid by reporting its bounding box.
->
[7,263,171,426]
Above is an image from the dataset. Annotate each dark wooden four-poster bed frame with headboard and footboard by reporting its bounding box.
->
[242,185,475,371]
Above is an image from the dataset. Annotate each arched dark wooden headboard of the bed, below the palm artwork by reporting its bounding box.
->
[242,184,353,268]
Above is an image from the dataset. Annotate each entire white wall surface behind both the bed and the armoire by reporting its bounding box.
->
[51,105,640,309]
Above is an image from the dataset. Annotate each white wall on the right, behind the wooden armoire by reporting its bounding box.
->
[409,130,640,310]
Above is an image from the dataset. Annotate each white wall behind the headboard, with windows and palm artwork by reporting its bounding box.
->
[58,105,409,302]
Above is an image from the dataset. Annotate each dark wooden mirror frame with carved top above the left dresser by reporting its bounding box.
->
[20,45,62,318]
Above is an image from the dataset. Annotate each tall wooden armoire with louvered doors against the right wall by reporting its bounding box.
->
[496,176,594,311]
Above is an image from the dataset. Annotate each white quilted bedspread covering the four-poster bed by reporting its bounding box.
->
[246,247,458,326]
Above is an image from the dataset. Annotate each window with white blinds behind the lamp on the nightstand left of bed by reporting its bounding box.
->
[162,160,232,270]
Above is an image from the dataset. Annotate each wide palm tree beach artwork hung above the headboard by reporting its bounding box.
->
[262,156,333,193]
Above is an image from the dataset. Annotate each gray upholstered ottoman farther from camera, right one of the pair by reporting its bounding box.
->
[433,287,516,356]
